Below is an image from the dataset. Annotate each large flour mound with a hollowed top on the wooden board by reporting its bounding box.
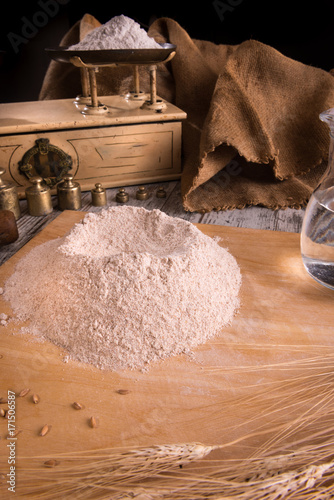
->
[4,206,241,371]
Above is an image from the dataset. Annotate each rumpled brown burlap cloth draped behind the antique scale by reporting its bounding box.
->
[40,15,334,211]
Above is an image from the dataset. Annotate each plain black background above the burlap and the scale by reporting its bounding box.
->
[0,0,334,102]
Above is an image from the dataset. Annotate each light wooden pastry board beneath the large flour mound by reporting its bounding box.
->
[0,211,334,498]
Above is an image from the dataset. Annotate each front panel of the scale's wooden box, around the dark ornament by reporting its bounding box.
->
[0,122,182,198]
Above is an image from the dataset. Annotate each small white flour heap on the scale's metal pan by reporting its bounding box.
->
[68,15,161,50]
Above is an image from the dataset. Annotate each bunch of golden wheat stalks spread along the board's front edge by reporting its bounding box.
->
[7,354,334,500]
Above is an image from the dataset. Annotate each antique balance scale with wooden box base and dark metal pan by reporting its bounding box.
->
[0,44,186,198]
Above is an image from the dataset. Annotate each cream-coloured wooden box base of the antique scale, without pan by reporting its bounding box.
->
[0,96,186,198]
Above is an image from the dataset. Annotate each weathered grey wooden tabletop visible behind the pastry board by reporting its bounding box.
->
[0,181,304,265]
